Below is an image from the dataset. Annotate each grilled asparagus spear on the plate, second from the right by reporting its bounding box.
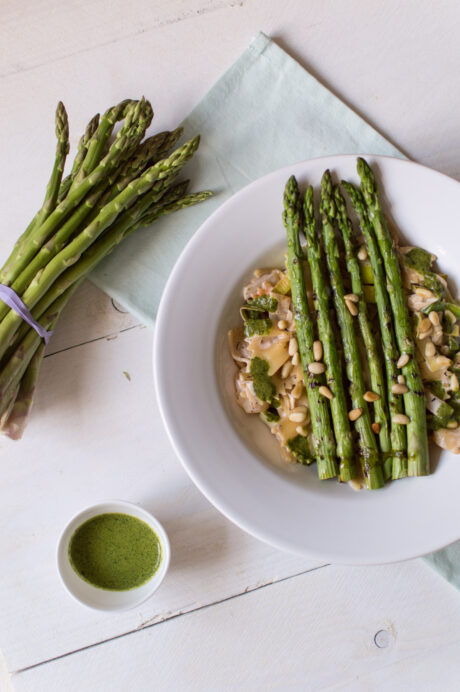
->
[342,181,407,480]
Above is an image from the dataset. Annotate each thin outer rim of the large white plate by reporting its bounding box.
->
[152,153,460,566]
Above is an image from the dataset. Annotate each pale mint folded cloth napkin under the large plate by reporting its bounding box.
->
[91,33,460,588]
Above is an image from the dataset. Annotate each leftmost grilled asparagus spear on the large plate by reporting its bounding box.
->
[283,176,338,480]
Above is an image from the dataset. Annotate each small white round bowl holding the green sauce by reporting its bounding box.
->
[56,500,171,611]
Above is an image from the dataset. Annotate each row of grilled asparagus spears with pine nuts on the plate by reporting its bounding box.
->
[283,159,429,489]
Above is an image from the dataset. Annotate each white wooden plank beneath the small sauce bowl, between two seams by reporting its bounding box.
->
[0,327,324,671]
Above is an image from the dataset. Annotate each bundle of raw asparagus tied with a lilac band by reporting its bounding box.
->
[0,98,211,439]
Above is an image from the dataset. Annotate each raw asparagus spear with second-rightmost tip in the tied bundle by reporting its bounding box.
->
[0,136,199,358]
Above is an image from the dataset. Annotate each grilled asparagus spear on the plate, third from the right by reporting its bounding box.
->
[334,181,393,480]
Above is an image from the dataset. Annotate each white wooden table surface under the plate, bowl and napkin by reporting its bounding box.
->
[0,0,460,692]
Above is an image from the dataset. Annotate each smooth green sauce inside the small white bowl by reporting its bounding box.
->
[69,513,161,591]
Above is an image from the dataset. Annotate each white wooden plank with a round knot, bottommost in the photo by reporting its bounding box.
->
[10,562,460,692]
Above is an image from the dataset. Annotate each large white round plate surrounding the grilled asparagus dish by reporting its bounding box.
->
[154,156,460,564]
